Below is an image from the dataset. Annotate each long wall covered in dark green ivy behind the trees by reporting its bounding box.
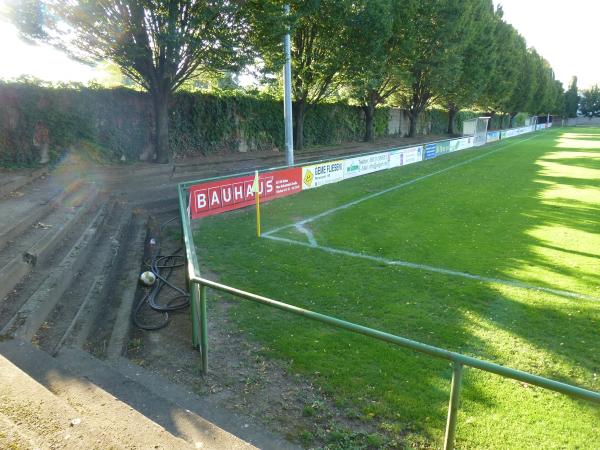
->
[0,82,520,166]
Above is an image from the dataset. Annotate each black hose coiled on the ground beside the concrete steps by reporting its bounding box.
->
[132,217,190,330]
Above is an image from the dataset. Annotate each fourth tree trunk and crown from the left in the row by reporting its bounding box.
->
[395,0,468,137]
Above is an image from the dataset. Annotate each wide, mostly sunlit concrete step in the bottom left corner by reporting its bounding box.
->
[0,340,192,449]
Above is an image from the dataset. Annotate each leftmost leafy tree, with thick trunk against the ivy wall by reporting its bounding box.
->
[12,0,250,163]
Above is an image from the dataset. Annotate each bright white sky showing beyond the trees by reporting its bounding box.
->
[0,0,600,88]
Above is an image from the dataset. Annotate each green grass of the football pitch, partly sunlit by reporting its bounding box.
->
[195,129,600,448]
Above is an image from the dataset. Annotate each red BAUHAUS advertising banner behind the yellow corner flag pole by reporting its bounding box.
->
[189,167,302,219]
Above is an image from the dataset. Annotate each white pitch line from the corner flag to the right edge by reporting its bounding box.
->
[265,236,600,302]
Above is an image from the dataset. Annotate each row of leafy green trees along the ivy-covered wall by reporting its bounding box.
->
[12,0,568,156]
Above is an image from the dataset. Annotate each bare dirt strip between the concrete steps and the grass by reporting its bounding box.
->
[127,216,396,449]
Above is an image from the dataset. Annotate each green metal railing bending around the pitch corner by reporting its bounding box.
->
[178,130,600,450]
